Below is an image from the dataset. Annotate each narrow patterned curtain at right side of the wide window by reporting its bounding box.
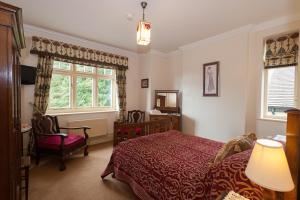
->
[116,69,126,122]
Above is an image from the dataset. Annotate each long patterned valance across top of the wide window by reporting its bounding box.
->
[30,36,128,70]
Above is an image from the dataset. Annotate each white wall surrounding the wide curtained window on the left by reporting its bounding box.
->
[21,25,140,137]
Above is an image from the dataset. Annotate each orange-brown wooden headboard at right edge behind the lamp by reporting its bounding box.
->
[284,109,300,200]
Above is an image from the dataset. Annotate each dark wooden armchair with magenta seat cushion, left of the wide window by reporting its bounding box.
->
[32,115,90,171]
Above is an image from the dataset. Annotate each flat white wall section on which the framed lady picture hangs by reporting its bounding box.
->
[181,27,249,141]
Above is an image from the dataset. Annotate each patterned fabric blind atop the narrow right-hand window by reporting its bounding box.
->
[265,32,299,68]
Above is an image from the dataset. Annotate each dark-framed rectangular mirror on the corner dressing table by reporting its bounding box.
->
[155,90,179,112]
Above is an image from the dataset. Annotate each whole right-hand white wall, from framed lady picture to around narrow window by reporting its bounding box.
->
[176,16,300,141]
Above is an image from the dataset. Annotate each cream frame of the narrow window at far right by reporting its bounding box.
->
[261,65,299,121]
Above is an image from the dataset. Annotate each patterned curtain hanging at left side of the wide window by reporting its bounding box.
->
[33,56,54,116]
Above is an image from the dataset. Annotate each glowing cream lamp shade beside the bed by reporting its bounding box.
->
[245,139,294,192]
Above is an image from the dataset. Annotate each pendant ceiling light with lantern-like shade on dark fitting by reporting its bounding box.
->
[136,1,151,45]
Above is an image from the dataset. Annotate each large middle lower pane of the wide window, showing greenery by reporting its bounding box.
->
[76,76,93,107]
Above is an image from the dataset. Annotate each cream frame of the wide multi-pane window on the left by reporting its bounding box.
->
[46,60,117,114]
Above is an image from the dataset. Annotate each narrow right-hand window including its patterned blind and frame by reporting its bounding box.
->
[261,32,299,119]
